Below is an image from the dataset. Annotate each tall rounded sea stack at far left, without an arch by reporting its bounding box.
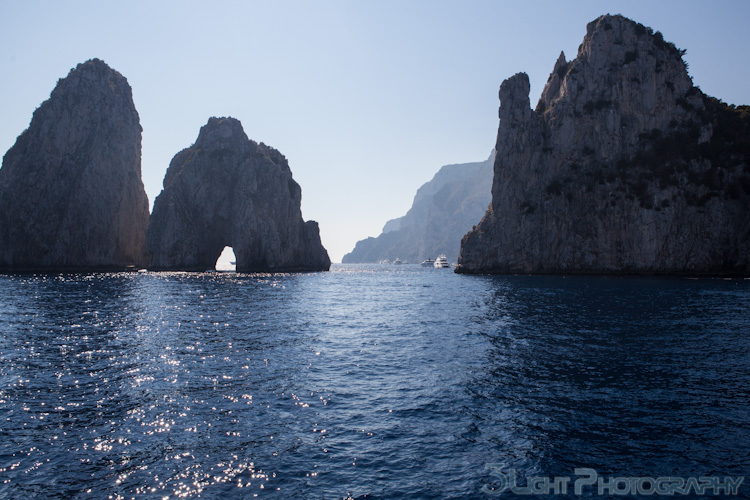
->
[0,59,149,271]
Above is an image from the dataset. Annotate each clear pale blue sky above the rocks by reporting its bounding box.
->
[0,0,750,262]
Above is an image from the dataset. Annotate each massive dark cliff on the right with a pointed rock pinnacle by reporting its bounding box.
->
[458,16,750,274]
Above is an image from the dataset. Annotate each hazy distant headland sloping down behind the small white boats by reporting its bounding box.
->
[342,151,495,263]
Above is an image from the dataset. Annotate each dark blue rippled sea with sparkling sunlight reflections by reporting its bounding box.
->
[0,265,750,499]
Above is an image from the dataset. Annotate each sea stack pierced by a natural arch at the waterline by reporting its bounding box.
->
[147,118,331,272]
